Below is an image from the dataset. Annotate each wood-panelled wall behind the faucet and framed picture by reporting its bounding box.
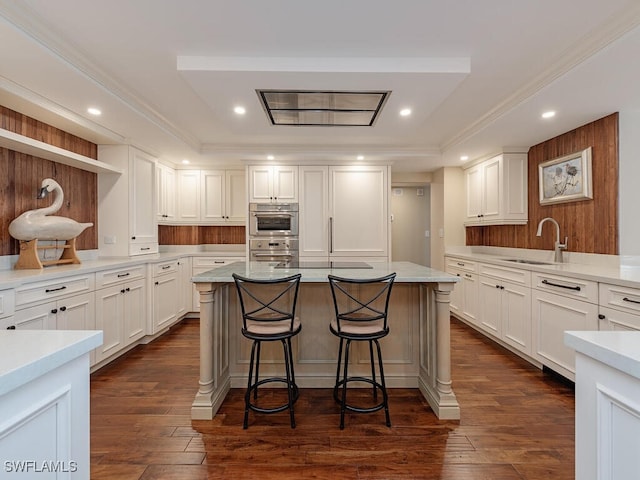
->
[466,113,619,255]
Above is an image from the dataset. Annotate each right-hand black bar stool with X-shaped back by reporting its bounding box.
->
[329,273,396,430]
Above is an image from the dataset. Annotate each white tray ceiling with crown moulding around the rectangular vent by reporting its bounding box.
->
[0,0,640,172]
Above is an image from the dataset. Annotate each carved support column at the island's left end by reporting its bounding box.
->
[191,283,231,420]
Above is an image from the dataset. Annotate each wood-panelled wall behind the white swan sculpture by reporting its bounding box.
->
[0,106,98,255]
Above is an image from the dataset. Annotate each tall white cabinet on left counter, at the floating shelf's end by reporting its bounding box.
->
[98,145,158,256]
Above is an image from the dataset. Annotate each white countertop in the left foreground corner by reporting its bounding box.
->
[0,330,102,396]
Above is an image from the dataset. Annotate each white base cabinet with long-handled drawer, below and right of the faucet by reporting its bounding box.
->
[532,272,598,380]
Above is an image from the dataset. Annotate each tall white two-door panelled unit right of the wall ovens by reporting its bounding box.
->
[299,166,389,259]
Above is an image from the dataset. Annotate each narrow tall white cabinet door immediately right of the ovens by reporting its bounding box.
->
[298,166,329,259]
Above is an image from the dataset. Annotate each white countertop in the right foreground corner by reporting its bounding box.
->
[564,331,640,379]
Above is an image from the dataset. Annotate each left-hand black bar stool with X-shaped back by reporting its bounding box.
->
[233,274,302,429]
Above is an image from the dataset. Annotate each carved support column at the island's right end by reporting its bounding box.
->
[418,283,460,420]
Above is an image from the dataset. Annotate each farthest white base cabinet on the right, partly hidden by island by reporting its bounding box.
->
[445,257,479,325]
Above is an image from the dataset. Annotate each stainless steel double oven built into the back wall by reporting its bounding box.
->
[249,203,298,263]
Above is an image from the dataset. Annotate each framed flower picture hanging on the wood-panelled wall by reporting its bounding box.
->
[538,147,593,205]
